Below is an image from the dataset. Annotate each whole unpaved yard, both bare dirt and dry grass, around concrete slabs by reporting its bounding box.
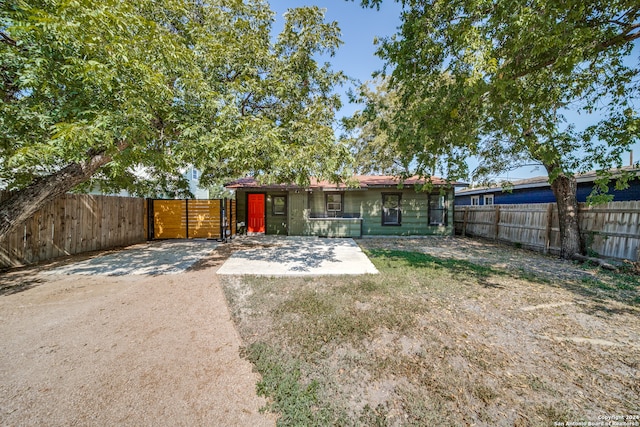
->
[0,238,640,426]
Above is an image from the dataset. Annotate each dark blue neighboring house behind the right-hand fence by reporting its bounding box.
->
[455,167,640,206]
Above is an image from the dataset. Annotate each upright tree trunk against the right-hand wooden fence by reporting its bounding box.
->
[551,175,583,259]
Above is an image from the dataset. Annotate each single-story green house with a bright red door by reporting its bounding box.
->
[225,175,464,237]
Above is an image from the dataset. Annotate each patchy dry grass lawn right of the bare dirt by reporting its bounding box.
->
[222,239,640,426]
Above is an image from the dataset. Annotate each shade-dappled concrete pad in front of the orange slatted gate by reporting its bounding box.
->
[48,240,220,276]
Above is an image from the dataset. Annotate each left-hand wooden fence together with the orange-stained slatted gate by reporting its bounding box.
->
[0,191,236,267]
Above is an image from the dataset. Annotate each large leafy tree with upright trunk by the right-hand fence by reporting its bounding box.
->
[361,0,640,258]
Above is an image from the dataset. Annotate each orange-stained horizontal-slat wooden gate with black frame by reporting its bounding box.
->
[148,199,236,239]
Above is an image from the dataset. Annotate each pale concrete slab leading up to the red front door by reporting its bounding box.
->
[218,236,378,276]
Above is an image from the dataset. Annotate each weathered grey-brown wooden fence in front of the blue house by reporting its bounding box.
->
[454,201,640,261]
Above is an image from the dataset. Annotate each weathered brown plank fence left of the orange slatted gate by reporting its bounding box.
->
[0,193,147,267]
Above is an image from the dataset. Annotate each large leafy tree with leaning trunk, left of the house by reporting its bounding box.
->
[0,0,347,239]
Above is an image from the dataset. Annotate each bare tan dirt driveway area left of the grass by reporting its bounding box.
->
[0,244,275,426]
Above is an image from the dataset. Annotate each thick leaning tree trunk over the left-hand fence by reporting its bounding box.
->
[0,153,111,240]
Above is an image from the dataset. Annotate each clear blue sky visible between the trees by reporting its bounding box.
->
[269,0,640,180]
